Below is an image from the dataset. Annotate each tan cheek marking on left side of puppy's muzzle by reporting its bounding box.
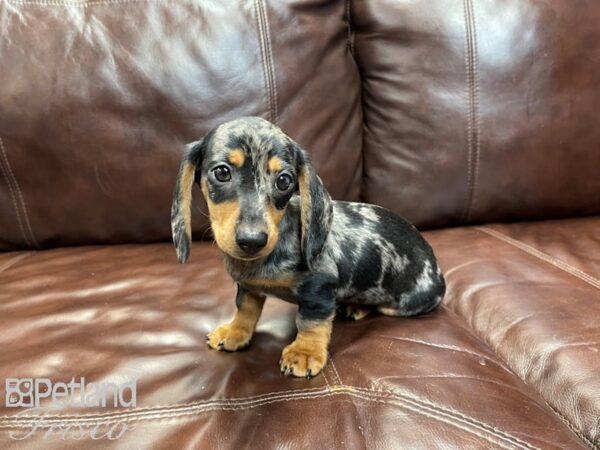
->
[201,180,240,255]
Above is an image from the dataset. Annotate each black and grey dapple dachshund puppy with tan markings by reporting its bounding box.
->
[171,117,446,378]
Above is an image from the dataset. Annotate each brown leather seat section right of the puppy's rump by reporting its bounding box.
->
[430,218,600,447]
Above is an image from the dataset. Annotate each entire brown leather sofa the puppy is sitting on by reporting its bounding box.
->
[0,0,600,450]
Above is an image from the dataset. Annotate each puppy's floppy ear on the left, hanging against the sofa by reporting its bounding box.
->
[171,139,205,264]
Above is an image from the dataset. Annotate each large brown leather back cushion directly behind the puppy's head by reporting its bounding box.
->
[0,0,362,250]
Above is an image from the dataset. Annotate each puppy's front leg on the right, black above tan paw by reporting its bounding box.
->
[279,277,335,378]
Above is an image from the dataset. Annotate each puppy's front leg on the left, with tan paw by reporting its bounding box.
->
[206,285,265,352]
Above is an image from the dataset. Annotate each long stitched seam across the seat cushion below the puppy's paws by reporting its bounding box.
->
[0,386,537,449]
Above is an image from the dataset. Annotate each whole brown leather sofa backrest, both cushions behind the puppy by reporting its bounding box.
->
[0,0,600,250]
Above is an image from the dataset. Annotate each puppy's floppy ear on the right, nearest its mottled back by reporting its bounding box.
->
[293,143,333,270]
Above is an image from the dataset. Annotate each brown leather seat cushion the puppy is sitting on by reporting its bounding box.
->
[0,243,597,449]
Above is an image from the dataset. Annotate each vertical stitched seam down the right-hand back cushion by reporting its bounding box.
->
[463,0,481,222]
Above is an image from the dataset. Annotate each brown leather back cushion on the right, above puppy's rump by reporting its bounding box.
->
[351,0,600,228]
